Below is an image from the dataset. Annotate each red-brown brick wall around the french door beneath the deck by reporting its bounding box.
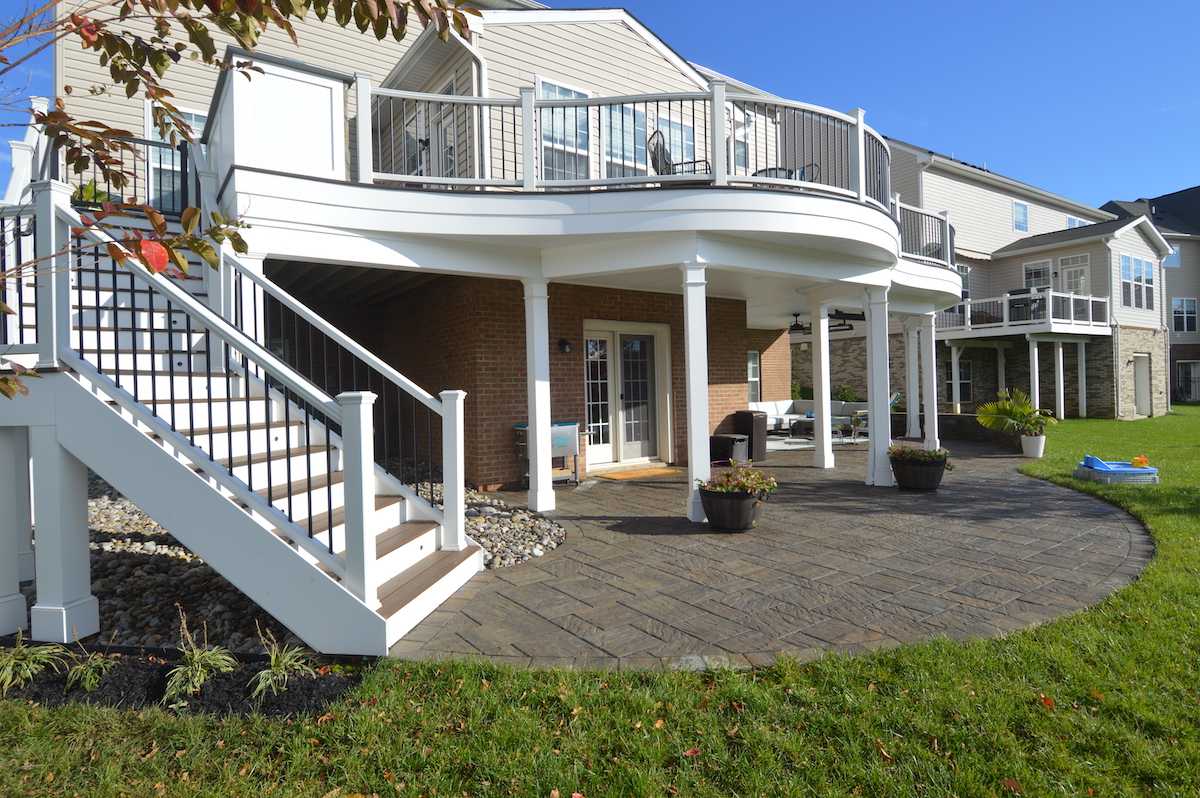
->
[292,276,791,487]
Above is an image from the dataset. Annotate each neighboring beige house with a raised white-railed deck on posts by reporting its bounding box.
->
[793,139,1169,418]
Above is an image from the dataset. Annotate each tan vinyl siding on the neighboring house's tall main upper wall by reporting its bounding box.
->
[922,166,1102,252]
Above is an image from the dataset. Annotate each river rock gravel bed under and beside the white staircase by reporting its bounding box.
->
[23,479,565,653]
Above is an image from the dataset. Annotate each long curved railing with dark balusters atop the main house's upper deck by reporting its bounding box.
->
[355,78,890,206]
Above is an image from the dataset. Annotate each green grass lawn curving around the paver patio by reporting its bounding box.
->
[0,408,1200,798]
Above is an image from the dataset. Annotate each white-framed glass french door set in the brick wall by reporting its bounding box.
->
[583,331,659,466]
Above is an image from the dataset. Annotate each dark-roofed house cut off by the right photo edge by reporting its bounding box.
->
[1102,186,1200,402]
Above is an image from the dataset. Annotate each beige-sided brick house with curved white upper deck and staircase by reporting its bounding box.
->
[0,2,962,653]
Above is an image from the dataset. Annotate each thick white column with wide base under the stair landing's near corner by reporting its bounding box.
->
[29,426,100,643]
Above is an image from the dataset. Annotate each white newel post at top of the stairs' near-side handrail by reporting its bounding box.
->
[31,180,71,368]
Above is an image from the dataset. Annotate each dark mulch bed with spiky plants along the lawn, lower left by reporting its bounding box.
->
[7,655,362,718]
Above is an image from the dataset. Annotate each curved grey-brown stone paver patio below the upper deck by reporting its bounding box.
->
[392,444,1153,668]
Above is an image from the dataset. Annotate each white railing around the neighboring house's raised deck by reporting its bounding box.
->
[937,290,1109,331]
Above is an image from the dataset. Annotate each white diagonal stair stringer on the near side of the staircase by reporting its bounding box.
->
[38,374,388,656]
